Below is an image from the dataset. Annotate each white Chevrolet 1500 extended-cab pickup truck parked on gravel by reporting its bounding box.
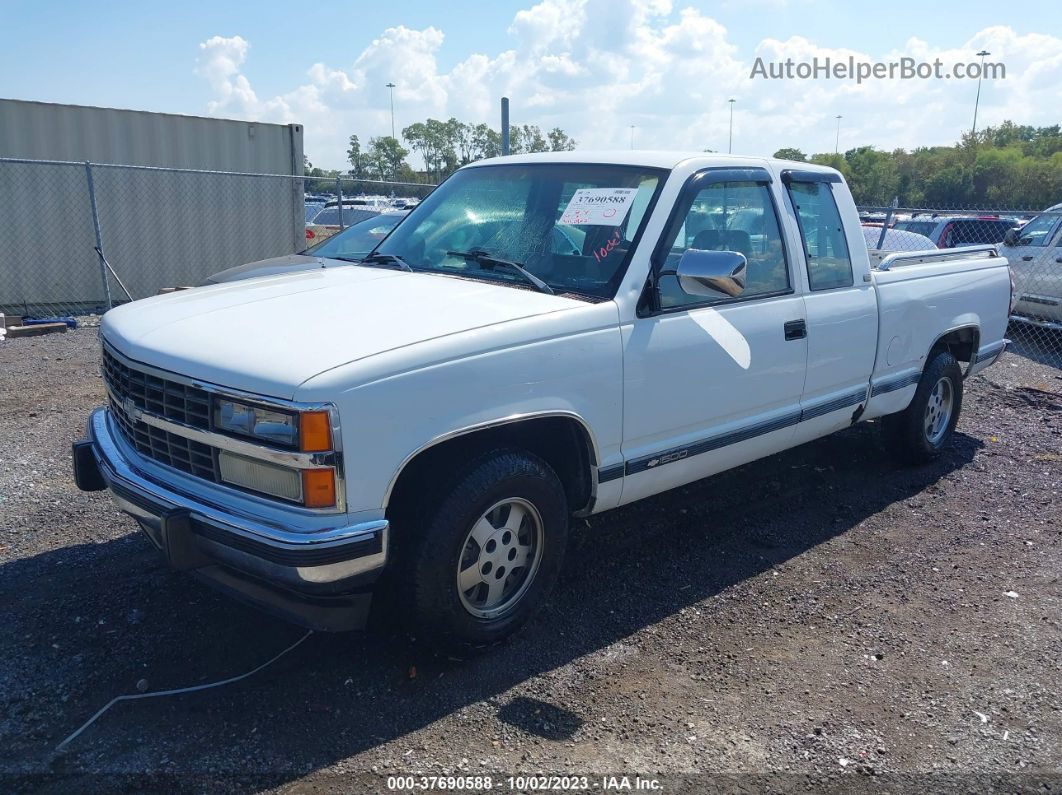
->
[74,152,1012,645]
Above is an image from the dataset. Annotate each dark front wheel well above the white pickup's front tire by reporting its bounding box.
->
[387,417,597,515]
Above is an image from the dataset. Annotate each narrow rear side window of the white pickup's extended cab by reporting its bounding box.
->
[789,182,855,290]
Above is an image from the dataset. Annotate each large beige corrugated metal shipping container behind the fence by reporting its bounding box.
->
[0,100,305,313]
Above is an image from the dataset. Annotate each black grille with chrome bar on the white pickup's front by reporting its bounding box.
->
[103,348,219,483]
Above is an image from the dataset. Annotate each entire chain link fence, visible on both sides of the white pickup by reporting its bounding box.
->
[0,158,1062,367]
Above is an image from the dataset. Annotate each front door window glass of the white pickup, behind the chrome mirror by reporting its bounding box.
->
[658,183,789,309]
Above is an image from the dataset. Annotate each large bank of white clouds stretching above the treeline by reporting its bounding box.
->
[195,5,1062,168]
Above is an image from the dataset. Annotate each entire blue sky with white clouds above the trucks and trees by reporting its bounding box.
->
[0,0,1062,168]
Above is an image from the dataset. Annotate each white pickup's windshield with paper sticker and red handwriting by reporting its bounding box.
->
[377,163,667,298]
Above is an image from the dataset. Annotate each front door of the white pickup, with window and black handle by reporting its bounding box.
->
[621,168,807,503]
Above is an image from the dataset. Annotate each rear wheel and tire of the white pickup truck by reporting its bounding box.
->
[884,350,962,464]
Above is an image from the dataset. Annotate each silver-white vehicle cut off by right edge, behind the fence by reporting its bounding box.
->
[999,204,1062,330]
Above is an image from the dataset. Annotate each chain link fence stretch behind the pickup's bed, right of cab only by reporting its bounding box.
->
[859,205,1062,367]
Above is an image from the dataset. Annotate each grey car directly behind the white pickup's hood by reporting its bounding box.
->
[201,212,407,287]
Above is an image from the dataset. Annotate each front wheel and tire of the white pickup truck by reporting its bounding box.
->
[395,449,568,649]
